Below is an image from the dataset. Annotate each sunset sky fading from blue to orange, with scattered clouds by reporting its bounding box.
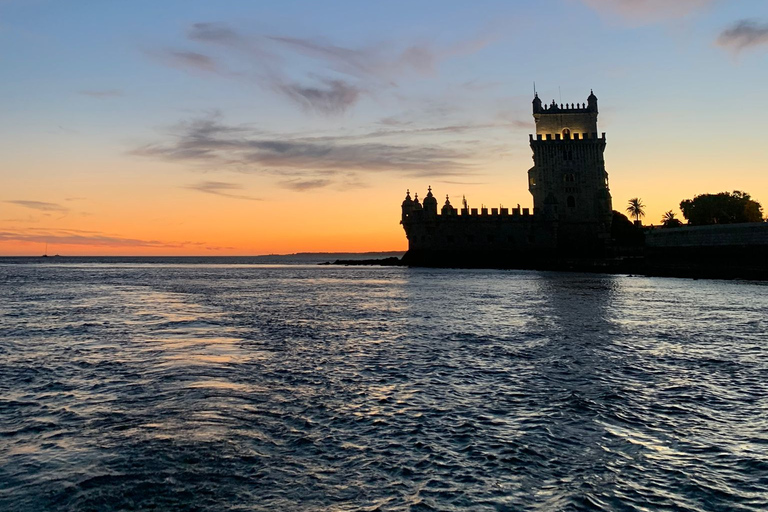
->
[0,0,768,256]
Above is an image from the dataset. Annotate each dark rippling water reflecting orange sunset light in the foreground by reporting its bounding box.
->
[0,261,768,511]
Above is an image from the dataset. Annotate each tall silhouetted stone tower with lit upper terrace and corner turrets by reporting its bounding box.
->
[528,93,612,249]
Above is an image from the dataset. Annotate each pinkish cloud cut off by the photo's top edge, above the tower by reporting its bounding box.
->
[582,0,714,23]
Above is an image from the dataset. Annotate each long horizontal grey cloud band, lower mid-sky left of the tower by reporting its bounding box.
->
[131,114,482,182]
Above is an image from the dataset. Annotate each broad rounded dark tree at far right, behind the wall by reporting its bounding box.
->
[680,190,763,226]
